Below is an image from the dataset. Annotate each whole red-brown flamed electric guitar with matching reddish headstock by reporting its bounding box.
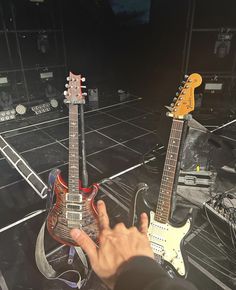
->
[47,72,98,246]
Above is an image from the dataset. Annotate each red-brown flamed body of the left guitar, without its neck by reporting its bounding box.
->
[47,170,98,246]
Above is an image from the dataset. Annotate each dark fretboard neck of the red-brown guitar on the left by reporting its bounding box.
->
[68,104,79,194]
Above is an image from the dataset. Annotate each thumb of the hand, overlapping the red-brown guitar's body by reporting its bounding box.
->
[70,229,98,265]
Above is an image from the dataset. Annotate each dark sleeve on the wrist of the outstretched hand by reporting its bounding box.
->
[114,256,197,290]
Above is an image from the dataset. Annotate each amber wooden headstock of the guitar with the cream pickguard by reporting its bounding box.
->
[167,73,202,119]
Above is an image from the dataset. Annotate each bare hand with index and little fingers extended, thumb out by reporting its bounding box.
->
[70,200,154,289]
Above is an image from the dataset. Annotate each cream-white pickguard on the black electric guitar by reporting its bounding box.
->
[148,211,191,276]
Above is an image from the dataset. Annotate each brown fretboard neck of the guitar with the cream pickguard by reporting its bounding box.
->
[155,119,184,223]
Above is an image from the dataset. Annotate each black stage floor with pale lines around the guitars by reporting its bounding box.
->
[0,97,236,290]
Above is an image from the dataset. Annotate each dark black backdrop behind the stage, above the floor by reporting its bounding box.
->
[0,0,236,111]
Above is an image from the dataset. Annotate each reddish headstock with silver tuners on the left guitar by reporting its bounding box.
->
[64,72,87,105]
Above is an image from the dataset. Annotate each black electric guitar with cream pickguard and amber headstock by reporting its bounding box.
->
[148,73,202,277]
